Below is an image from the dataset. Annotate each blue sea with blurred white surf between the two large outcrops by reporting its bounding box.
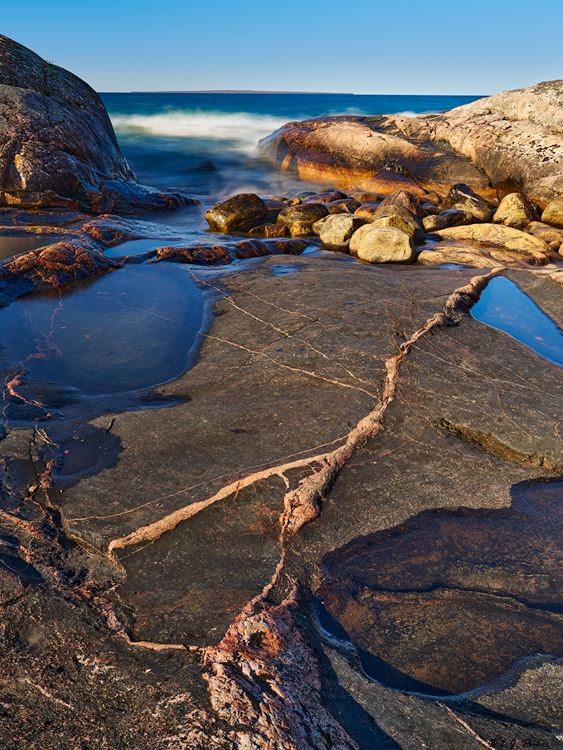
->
[101,93,479,216]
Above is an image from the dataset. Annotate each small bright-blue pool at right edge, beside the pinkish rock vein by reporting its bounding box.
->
[471,276,563,365]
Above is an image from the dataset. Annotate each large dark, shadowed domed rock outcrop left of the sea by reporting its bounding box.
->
[0,35,190,213]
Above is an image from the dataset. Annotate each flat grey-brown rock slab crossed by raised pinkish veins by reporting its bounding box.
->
[0,254,563,750]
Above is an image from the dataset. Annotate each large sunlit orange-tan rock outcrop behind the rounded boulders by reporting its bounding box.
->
[261,81,563,208]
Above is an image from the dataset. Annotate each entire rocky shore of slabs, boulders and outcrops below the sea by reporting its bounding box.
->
[0,37,563,750]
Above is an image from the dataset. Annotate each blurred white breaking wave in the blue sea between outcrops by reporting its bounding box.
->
[111,110,288,152]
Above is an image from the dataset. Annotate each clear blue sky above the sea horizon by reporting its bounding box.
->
[0,0,563,95]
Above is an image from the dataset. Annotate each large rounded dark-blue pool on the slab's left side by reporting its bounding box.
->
[0,263,204,395]
